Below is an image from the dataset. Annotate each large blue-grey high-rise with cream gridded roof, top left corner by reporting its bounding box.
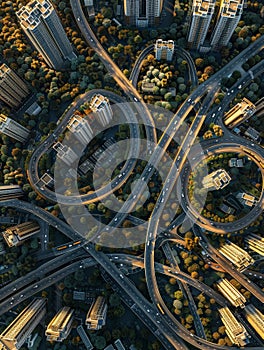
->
[17,0,75,69]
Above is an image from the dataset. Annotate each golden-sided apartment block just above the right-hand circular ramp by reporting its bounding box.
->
[224,97,256,129]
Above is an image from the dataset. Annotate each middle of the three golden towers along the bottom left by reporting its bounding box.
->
[45,306,74,342]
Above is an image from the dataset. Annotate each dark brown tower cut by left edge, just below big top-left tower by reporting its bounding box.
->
[0,63,30,108]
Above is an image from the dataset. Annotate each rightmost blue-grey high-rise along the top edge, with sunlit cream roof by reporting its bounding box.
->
[210,0,244,49]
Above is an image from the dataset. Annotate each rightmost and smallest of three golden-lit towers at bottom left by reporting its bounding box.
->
[85,296,107,330]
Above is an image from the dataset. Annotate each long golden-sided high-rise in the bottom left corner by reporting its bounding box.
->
[0,298,46,350]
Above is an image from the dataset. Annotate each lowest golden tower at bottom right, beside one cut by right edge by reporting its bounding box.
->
[218,307,249,346]
